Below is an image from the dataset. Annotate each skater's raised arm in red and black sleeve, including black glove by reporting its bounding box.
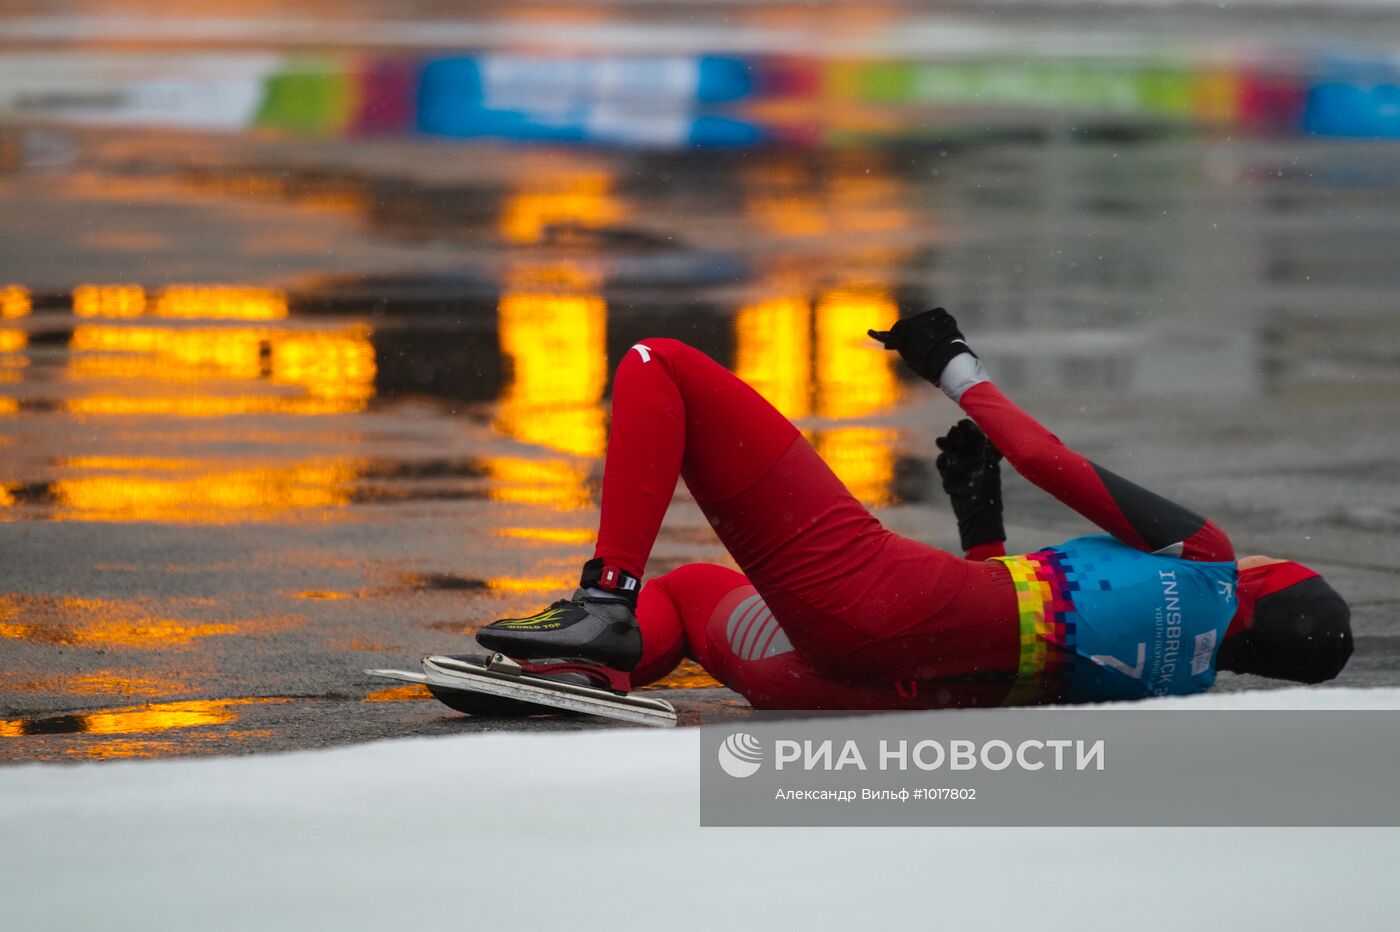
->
[871,309,1235,561]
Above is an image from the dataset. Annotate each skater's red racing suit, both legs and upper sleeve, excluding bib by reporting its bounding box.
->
[595,339,1233,708]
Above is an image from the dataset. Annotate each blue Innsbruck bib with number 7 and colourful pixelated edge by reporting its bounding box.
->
[998,535,1238,702]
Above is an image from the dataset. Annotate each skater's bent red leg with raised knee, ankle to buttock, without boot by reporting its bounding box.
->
[595,339,967,663]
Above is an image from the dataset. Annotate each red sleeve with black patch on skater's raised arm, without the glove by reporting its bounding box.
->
[949,377,1235,560]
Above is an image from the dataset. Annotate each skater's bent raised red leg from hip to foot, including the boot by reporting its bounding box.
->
[477,339,1019,682]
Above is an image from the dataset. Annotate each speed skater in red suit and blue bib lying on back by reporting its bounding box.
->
[477,308,1352,709]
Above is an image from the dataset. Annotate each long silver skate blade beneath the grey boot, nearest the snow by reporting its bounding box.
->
[423,656,676,728]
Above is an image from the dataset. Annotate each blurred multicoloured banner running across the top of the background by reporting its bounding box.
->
[0,52,1400,148]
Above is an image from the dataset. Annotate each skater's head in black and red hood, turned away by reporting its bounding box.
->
[1218,557,1352,683]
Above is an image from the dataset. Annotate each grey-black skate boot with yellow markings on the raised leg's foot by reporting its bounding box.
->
[476,558,641,672]
